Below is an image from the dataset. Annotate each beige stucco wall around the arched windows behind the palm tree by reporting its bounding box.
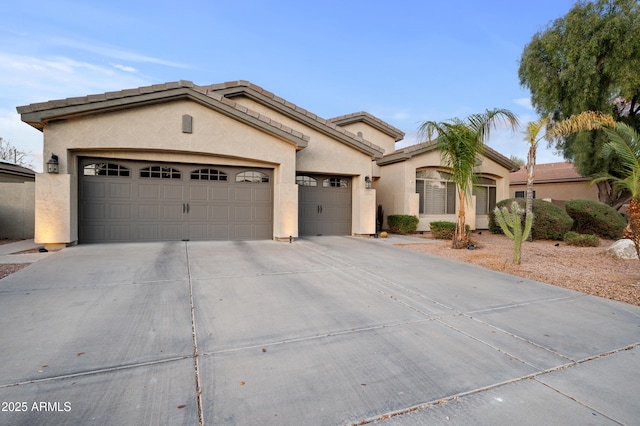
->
[376,150,509,231]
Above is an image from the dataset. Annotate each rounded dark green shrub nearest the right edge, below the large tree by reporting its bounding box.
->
[564,200,627,240]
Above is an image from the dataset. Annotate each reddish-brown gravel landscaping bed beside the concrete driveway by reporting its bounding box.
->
[401,231,640,306]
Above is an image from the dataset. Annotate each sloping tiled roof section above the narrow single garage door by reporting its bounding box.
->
[208,80,384,159]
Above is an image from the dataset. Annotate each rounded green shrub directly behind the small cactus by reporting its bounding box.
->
[489,198,573,240]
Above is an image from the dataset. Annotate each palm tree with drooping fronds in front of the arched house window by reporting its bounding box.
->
[418,109,518,248]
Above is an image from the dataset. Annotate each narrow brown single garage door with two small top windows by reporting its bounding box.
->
[296,175,351,236]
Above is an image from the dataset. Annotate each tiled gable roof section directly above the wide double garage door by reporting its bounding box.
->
[16,80,309,149]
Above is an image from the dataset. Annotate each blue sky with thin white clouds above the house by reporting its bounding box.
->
[0,0,574,170]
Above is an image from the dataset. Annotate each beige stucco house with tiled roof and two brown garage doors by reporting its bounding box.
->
[17,81,514,248]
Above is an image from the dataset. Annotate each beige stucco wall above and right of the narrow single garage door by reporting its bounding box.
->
[233,97,376,235]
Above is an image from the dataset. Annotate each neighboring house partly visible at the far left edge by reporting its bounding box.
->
[0,160,36,239]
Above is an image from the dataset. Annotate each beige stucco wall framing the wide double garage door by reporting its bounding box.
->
[35,100,298,244]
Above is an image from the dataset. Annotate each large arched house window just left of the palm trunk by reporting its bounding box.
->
[416,170,456,214]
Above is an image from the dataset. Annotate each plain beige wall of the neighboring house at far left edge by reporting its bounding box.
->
[0,179,36,239]
